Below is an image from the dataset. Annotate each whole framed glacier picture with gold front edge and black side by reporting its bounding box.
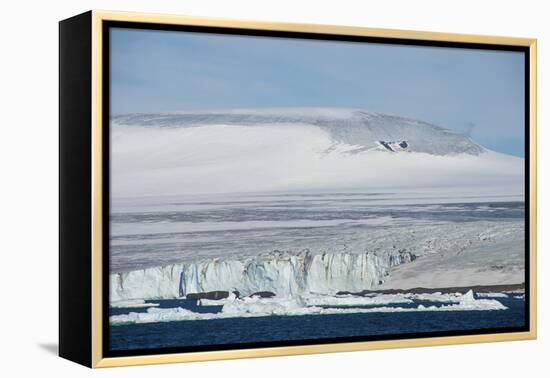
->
[59,11,536,367]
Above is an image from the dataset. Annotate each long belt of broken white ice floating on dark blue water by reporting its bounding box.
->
[110,290,507,325]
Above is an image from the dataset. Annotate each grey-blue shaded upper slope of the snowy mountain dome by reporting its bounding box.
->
[112,108,485,155]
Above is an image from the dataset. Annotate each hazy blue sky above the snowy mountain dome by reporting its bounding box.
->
[111,28,524,156]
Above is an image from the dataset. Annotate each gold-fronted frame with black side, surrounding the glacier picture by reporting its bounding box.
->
[60,10,537,368]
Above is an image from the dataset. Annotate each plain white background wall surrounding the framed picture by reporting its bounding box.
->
[0,0,550,377]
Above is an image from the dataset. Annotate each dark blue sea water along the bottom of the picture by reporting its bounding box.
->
[109,296,525,351]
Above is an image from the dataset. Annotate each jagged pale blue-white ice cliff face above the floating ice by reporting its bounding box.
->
[110,251,414,302]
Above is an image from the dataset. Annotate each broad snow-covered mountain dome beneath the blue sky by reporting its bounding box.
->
[111,108,524,197]
